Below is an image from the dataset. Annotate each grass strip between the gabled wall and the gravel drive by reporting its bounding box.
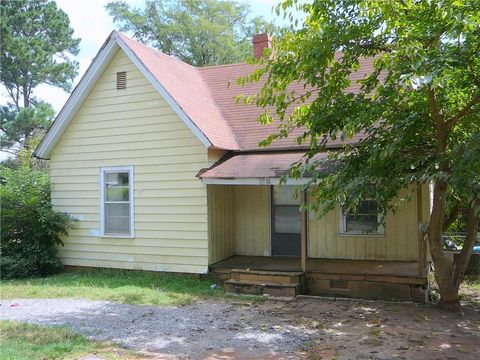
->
[0,269,225,306]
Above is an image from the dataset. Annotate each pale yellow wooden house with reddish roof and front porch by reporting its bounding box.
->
[35,31,429,300]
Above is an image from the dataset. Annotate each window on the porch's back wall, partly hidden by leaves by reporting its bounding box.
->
[340,199,385,235]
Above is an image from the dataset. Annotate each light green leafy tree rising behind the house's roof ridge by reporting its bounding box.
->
[106,0,272,66]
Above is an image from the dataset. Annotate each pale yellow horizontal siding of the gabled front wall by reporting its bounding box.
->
[50,50,208,273]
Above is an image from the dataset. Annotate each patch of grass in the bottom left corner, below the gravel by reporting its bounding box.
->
[0,321,137,360]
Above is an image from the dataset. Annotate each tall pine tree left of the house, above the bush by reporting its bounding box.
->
[0,0,80,150]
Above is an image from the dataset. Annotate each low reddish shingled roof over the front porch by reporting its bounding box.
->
[197,151,328,185]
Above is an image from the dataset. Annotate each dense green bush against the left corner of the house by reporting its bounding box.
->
[0,166,73,279]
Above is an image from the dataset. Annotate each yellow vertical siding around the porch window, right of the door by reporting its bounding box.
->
[308,190,418,260]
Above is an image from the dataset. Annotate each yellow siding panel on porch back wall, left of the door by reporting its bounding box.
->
[234,185,271,256]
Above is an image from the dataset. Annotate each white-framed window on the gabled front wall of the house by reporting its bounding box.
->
[100,166,134,238]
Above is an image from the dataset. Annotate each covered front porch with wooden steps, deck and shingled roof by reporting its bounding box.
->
[199,152,429,301]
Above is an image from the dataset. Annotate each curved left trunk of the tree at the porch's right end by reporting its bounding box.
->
[428,180,461,311]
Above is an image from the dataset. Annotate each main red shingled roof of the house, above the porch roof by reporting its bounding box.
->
[120,35,372,151]
